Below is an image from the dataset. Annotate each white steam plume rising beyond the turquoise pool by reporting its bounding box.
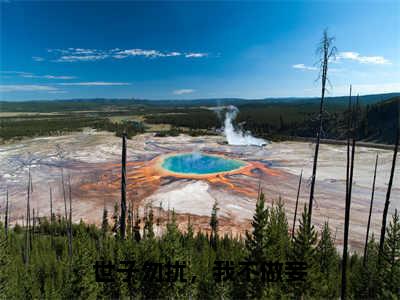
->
[224,105,267,146]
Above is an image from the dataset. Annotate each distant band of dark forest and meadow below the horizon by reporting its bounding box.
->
[0,94,400,144]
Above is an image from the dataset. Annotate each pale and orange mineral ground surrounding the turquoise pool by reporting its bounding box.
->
[0,130,400,250]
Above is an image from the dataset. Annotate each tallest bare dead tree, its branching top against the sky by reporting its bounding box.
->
[308,30,336,226]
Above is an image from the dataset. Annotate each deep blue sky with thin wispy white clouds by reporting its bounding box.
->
[0,0,400,101]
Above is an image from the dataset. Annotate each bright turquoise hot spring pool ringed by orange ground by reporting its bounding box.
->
[161,153,246,175]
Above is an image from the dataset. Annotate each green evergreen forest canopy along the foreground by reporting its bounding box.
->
[0,193,400,299]
